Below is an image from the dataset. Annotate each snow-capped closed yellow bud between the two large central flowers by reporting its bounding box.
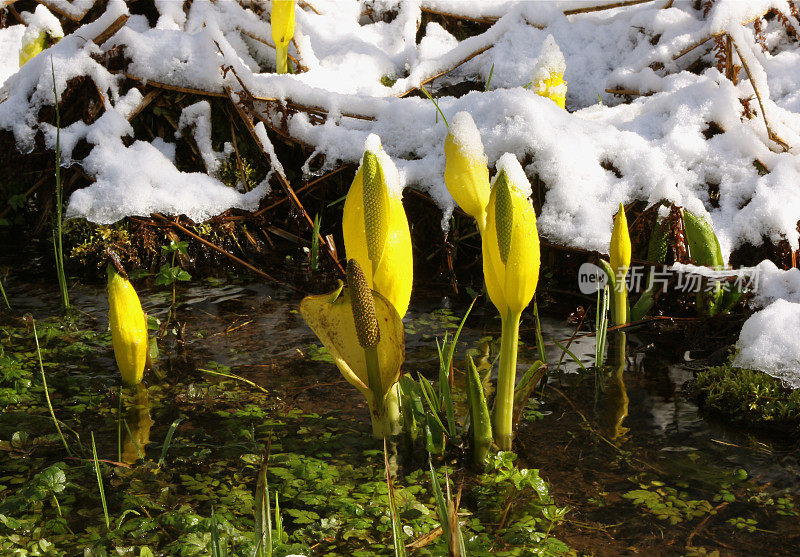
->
[444,112,490,235]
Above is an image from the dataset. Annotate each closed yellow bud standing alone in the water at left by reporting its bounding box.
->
[108,271,148,385]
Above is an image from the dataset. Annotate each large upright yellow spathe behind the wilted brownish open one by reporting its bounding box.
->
[342,134,413,318]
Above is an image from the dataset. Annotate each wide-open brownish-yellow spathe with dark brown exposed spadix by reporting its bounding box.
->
[300,259,405,438]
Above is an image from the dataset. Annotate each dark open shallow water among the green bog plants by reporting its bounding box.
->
[1,279,800,555]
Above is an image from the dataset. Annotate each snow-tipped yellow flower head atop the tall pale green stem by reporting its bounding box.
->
[483,153,539,315]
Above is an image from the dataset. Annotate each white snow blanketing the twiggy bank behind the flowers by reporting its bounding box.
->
[0,0,800,382]
